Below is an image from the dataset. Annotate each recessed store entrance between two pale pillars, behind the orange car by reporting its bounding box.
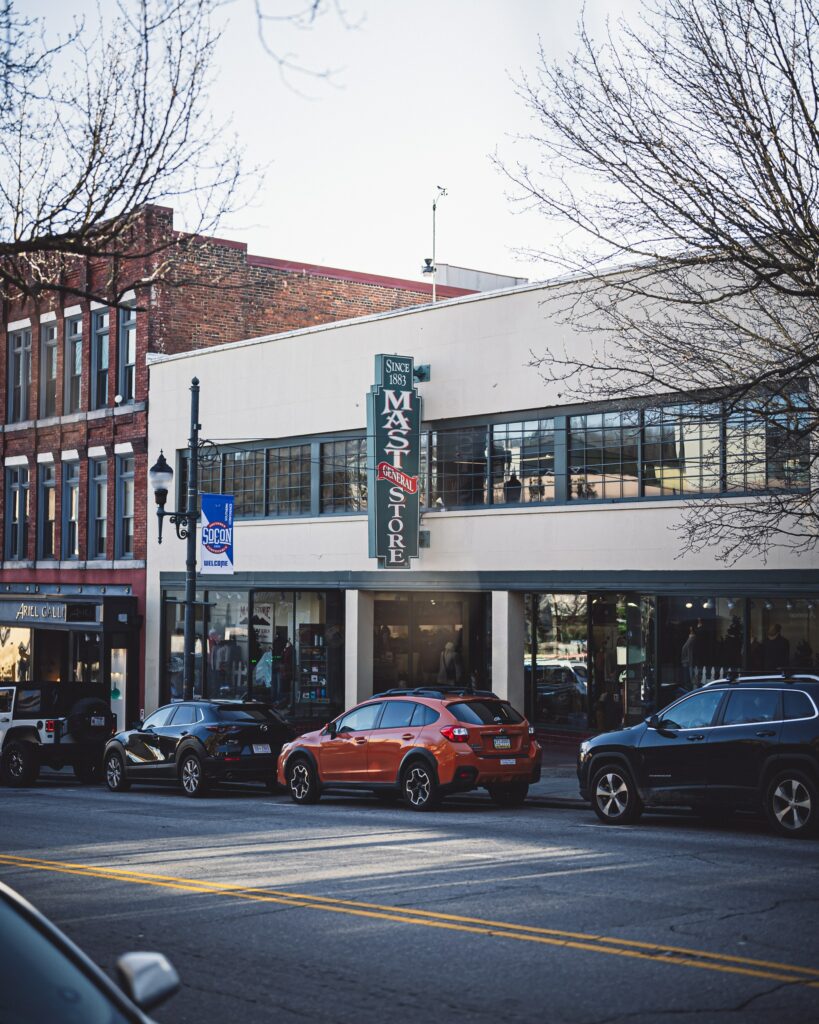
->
[373,593,491,693]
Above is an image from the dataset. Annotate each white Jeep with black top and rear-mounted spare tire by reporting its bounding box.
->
[0,683,115,785]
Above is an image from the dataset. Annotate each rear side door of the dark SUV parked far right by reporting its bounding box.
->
[706,686,782,805]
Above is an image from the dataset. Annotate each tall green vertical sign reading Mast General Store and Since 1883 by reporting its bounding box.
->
[367,355,421,569]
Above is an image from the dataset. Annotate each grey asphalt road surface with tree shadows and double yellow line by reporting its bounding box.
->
[0,778,819,1024]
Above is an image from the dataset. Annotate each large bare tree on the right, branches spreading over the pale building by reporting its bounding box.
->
[503,0,819,561]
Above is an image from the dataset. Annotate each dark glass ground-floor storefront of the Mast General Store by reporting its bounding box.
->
[151,570,819,736]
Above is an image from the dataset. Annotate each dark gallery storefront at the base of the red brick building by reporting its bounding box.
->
[0,583,141,728]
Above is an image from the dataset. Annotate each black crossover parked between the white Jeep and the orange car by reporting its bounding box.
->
[103,700,295,797]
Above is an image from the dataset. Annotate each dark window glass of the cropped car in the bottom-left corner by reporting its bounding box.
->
[0,898,135,1024]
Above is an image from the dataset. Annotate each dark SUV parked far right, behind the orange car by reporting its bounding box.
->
[577,675,819,838]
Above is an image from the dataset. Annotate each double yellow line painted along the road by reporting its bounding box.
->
[0,854,819,988]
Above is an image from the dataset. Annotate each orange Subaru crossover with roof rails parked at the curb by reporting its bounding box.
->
[278,689,542,811]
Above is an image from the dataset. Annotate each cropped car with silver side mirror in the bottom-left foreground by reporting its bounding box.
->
[0,882,179,1024]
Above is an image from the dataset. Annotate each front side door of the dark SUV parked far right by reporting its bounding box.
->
[638,689,725,804]
